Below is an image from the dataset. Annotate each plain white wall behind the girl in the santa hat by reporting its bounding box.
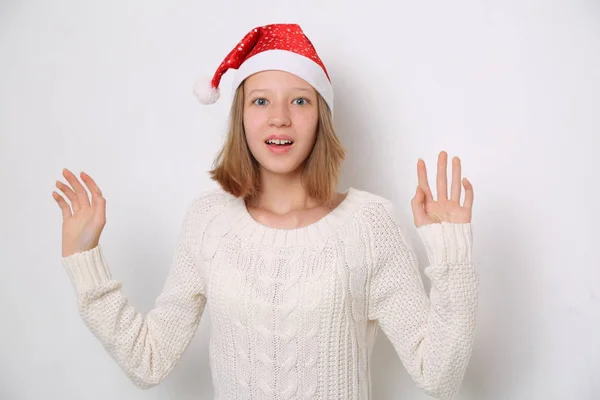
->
[0,0,600,400]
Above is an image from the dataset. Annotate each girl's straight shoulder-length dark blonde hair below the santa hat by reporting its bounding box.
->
[209,83,346,206]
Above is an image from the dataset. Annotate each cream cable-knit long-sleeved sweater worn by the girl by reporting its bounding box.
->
[62,188,478,400]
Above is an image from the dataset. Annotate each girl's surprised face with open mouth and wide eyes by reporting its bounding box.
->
[244,71,318,174]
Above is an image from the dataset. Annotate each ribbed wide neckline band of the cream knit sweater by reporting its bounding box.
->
[225,187,362,247]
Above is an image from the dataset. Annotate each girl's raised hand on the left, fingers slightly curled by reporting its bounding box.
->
[52,168,106,257]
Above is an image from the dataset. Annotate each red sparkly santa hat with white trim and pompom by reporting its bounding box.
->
[194,24,333,113]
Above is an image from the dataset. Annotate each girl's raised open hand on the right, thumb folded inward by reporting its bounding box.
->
[411,151,473,227]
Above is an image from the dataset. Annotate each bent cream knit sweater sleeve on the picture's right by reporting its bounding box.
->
[368,202,478,400]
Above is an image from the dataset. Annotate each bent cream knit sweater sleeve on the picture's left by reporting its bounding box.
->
[62,200,206,389]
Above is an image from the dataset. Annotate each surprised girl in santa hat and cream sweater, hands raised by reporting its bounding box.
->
[53,24,478,400]
